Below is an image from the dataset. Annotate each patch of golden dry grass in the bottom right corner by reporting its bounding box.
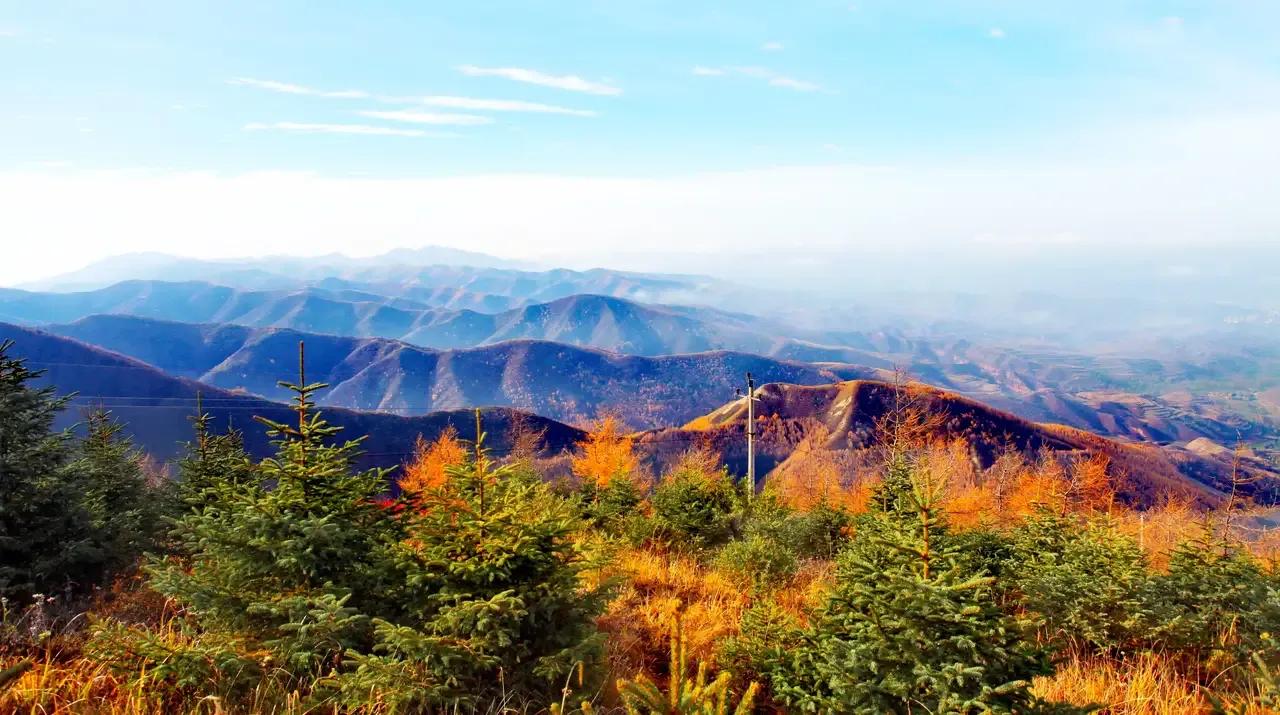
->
[1034,654,1275,715]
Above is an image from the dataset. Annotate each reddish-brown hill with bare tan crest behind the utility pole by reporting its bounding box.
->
[640,380,1280,505]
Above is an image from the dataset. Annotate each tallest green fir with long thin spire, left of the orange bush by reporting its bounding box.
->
[144,365,403,689]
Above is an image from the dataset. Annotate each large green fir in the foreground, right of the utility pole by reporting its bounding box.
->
[773,460,1051,712]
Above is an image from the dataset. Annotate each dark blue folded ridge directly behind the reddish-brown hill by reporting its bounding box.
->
[46,316,876,428]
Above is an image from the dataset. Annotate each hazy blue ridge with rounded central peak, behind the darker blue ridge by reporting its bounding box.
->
[0,281,777,354]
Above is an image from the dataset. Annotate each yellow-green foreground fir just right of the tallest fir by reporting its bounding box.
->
[338,426,604,711]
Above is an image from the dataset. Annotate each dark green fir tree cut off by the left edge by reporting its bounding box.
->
[0,340,101,600]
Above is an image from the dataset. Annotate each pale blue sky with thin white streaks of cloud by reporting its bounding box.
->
[0,0,1280,285]
